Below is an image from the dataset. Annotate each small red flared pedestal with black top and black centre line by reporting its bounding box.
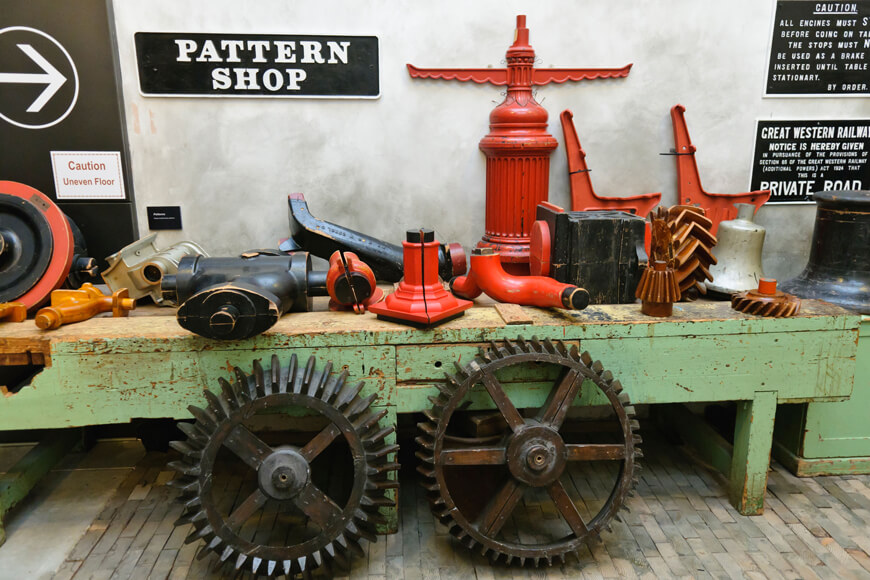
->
[369,229,473,327]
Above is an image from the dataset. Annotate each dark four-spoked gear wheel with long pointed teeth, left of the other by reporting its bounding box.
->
[169,355,399,578]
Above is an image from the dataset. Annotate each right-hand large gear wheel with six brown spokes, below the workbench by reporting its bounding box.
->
[417,337,642,566]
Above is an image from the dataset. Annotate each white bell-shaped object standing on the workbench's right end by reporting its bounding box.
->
[706,203,767,294]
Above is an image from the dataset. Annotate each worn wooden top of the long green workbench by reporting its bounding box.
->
[0,300,860,364]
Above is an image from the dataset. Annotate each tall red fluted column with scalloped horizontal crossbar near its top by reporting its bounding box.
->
[408,15,631,275]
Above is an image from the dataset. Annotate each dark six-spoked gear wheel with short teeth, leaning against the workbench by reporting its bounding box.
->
[417,338,641,566]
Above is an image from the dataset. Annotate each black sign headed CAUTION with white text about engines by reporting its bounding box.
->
[765,0,870,96]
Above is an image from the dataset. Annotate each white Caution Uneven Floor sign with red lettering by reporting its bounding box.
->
[51,151,127,199]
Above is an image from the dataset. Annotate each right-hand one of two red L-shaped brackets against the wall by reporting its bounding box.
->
[671,105,770,236]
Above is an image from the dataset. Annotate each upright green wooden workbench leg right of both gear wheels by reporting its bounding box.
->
[729,391,776,516]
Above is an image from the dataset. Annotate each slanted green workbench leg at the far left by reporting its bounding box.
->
[0,429,80,546]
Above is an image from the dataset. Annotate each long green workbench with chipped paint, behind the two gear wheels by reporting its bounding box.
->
[0,301,860,540]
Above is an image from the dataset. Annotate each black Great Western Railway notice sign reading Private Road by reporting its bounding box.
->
[749,119,870,203]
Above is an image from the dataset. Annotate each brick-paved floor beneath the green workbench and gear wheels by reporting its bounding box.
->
[52,434,870,580]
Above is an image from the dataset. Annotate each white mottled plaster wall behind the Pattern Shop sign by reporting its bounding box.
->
[114,0,870,279]
